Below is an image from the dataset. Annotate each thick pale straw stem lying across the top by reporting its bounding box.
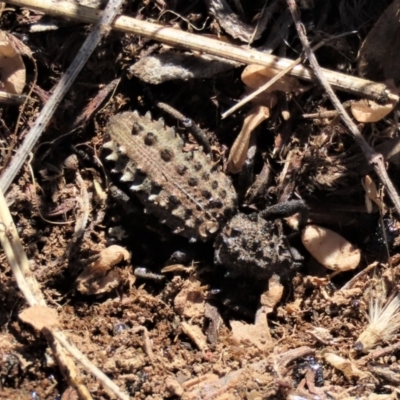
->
[4,0,399,101]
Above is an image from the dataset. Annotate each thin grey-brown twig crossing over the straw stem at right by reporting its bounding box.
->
[287,0,400,219]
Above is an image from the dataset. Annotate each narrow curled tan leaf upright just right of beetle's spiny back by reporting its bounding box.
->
[226,106,270,174]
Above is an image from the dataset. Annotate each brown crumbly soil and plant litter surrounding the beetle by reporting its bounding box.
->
[0,0,400,400]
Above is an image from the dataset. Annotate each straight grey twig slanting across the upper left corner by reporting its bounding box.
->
[0,0,122,192]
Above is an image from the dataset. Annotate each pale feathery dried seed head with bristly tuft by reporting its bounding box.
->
[354,295,400,351]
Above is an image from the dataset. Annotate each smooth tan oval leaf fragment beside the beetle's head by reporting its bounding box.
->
[301,225,361,271]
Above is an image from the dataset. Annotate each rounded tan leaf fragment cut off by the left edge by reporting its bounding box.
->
[0,31,26,94]
